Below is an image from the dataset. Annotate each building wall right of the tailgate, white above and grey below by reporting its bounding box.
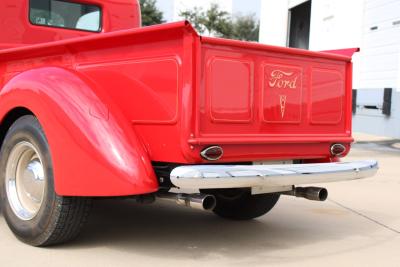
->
[353,0,400,138]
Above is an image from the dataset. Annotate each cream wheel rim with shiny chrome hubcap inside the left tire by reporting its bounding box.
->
[6,141,46,221]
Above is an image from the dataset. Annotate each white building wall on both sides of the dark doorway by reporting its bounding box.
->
[260,0,364,50]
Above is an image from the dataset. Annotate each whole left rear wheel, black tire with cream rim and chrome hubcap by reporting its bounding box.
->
[0,115,91,246]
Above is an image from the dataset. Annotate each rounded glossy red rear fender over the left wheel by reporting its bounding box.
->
[0,67,158,196]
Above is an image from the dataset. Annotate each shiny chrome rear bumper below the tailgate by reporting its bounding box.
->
[170,160,378,192]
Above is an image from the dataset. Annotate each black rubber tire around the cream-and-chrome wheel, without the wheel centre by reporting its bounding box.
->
[0,115,91,246]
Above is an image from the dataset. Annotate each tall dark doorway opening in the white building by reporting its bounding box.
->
[288,1,311,49]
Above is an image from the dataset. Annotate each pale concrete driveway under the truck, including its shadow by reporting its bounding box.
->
[0,137,400,267]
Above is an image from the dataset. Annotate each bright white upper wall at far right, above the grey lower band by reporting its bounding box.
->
[357,0,400,89]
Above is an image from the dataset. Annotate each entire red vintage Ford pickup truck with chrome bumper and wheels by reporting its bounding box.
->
[0,0,377,246]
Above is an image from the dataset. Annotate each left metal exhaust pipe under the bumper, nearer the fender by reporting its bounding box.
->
[157,193,217,210]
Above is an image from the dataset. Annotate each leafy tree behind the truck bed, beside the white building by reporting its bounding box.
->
[180,4,260,41]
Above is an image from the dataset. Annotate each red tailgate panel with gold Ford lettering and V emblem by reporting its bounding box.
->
[195,37,352,144]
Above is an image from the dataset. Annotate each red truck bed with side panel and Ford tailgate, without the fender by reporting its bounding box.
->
[0,22,352,168]
